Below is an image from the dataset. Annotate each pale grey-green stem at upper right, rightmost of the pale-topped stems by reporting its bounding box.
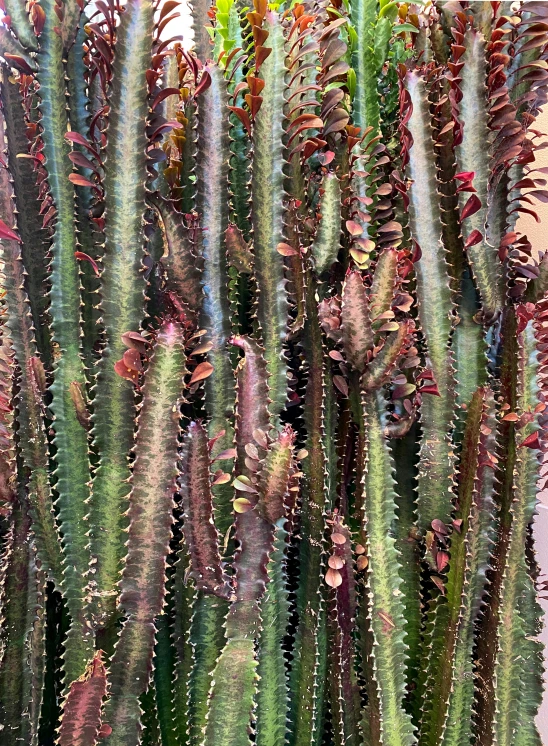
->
[455,29,503,321]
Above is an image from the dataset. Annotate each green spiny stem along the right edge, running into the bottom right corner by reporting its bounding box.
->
[493,315,542,746]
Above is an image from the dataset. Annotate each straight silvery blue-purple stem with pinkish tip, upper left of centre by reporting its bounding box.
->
[196,64,235,535]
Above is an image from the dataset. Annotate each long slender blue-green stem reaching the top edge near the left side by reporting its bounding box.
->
[36,0,93,684]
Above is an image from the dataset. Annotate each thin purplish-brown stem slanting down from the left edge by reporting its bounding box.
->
[0,94,62,584]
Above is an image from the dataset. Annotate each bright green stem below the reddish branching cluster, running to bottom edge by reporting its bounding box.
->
[362,392,416,746]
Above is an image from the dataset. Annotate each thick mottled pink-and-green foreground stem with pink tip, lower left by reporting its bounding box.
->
[103,319,186,746]
